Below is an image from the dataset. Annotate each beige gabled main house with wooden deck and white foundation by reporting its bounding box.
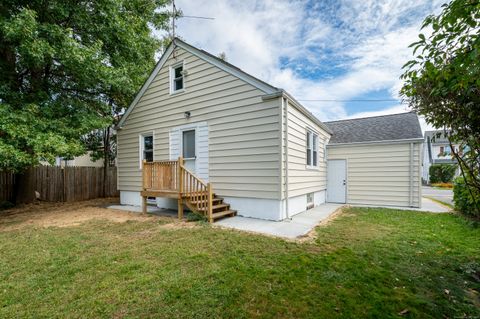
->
[117,39,419,221]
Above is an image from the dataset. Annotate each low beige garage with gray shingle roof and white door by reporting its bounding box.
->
[325,113,423,207]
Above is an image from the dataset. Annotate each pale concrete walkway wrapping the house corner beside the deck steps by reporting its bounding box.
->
[215,204,343,239]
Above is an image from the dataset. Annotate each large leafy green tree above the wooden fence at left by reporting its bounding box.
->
[0,0,170,172]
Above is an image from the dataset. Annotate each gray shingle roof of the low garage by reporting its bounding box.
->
[324,112,423,144]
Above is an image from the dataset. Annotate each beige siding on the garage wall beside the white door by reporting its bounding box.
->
[328,143,422,207]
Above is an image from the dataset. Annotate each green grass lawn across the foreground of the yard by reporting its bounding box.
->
[0,208,480,318]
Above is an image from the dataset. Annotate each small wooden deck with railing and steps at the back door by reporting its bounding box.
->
[141,157,237,223]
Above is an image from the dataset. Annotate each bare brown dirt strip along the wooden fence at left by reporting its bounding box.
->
[0,198,170,231]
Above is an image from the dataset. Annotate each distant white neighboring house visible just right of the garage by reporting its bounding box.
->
[422,130,460,183]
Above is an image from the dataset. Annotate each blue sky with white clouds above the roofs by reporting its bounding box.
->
[171,0,446,129]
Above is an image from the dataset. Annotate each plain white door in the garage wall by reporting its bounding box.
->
[327,160,347,204]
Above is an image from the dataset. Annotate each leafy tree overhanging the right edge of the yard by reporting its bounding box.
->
[401,0,480,215]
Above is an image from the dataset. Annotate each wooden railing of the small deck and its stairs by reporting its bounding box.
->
[143,157,213,222]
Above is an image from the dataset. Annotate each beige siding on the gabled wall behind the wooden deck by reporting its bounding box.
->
[118,48,280,199]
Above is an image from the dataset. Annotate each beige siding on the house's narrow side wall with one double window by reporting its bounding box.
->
[282,103,330,197]
